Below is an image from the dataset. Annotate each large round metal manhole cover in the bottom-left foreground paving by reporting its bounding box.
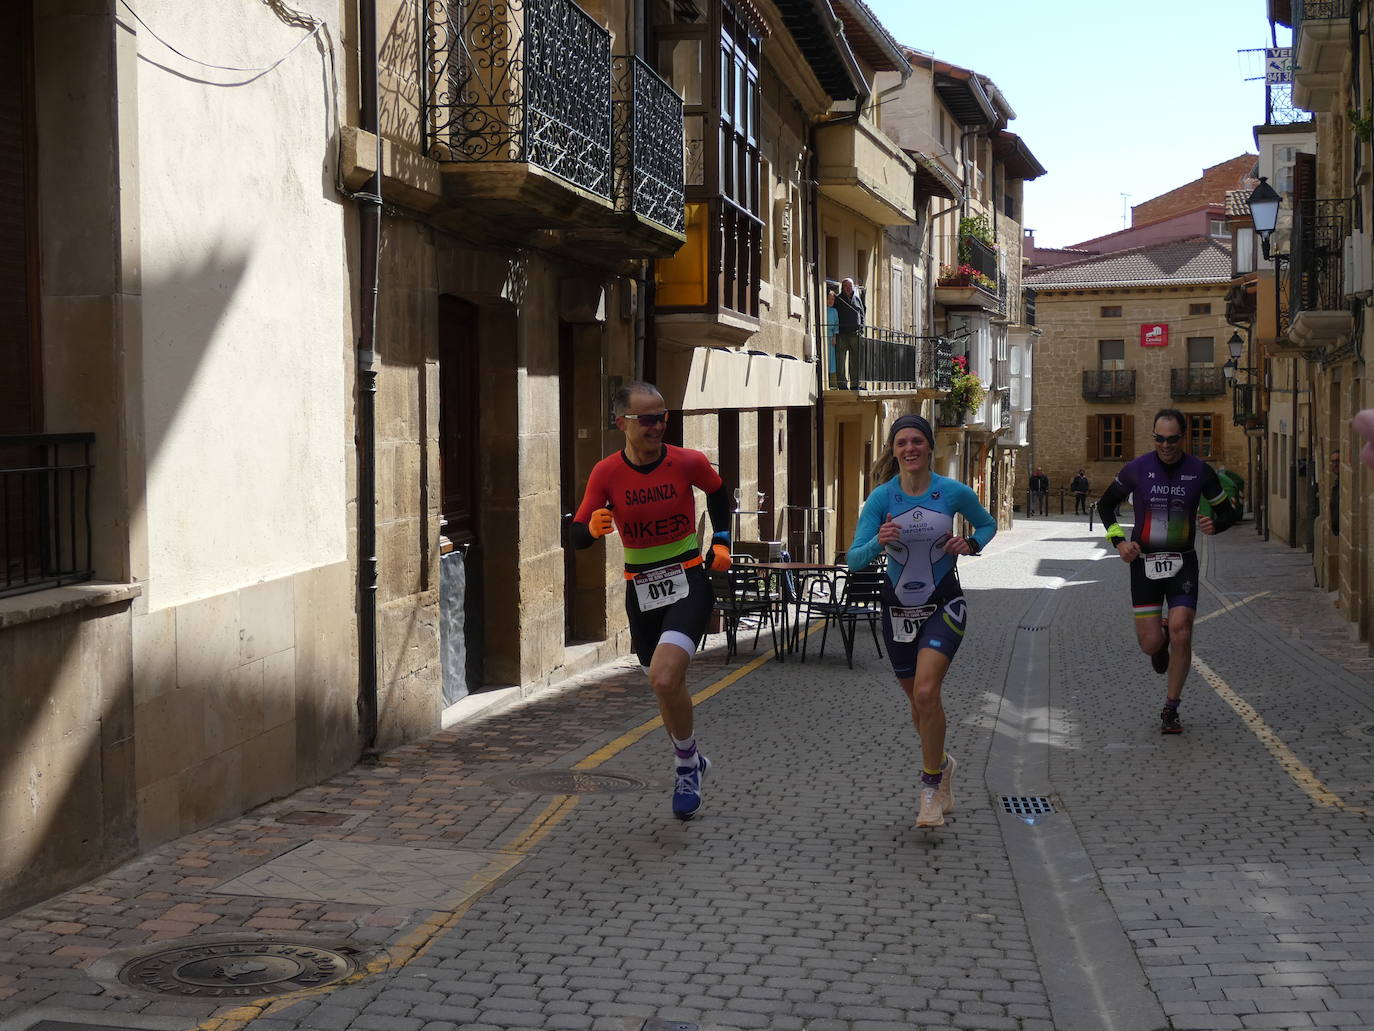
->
[120,942,353,998]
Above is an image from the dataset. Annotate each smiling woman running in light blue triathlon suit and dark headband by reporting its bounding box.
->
[845,415,998,828]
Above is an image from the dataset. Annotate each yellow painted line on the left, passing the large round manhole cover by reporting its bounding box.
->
[192,627,796,1031]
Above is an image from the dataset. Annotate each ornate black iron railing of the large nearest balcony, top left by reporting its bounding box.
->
[425,0,613,198]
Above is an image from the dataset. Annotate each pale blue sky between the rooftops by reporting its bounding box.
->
[867,0,1287,246]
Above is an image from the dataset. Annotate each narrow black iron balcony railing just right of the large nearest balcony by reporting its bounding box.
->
[614,56,686,232]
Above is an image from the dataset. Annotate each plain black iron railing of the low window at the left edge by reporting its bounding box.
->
[0,433,95,598]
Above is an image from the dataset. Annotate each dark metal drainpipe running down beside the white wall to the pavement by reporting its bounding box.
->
[354,0,382,757]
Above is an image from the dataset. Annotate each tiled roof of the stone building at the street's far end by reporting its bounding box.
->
[1022,236,1231,290]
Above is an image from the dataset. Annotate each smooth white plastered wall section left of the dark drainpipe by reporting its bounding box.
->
[129,0,350,609]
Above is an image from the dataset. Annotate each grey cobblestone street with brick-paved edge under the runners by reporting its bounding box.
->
[0,517,1374,1031]
